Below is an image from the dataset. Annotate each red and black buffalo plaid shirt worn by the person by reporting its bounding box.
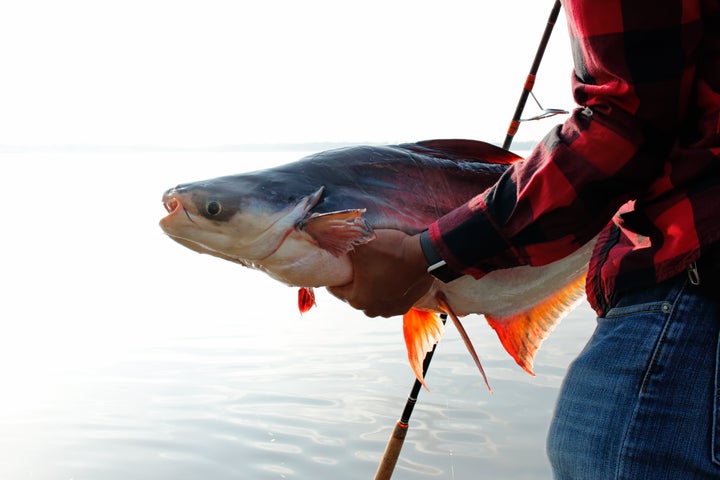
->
[429,0,720,314]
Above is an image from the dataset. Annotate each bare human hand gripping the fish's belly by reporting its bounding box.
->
[327,230,433,317]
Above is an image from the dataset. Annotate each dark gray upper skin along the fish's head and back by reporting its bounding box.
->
[166,140,518,233]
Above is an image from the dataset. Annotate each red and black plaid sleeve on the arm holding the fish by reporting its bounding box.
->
[428,0,702,278]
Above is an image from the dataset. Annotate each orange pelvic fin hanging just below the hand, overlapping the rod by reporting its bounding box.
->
[403,308,443,390]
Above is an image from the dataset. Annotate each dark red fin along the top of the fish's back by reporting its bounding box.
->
[400,139,522,165]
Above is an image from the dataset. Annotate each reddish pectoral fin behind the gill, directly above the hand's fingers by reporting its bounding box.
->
[299,209,375,257]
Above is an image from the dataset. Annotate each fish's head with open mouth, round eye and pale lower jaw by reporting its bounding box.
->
[160,176,323,268]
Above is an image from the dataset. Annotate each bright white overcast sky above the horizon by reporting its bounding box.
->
[0,0,573,147]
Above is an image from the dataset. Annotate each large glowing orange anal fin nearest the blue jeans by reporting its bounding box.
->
[485,275,585,375]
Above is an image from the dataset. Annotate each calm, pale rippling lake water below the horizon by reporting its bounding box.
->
[0,150,594,480]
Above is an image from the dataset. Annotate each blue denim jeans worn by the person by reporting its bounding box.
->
[547,275,720,480]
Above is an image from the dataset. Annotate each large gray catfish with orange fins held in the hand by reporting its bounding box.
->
[160,139,592,391]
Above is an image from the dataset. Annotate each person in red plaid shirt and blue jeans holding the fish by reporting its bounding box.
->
[329,0,720,480]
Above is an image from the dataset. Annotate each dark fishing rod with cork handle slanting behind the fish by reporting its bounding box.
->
[374,0,568,480]
